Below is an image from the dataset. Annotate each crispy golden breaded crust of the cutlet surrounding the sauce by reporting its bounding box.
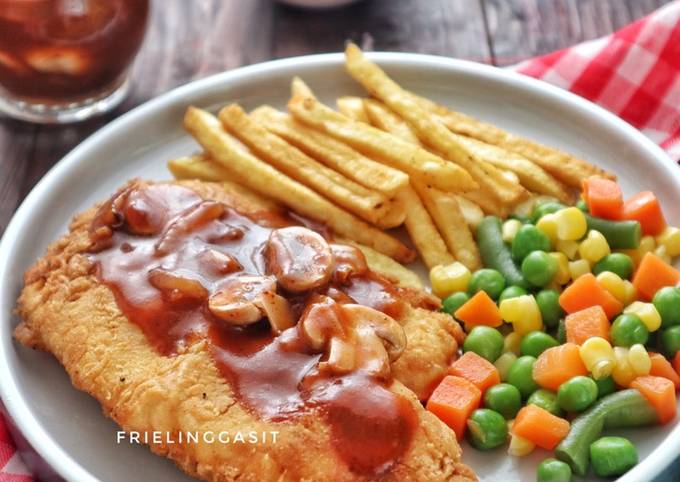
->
[15,182,475,481]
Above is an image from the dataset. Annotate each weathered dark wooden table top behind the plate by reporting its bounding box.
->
[0,0,668,234]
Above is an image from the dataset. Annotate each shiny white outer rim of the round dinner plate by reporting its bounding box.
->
[0,52,680,482]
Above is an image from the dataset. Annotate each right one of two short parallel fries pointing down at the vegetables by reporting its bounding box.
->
[413,181,482,271]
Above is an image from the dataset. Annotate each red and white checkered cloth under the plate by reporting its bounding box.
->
[0,0,680,482]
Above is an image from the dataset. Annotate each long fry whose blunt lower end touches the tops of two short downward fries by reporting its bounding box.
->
[250,106,409,198]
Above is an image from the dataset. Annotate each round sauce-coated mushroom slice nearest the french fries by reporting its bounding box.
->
[266,226,333,293]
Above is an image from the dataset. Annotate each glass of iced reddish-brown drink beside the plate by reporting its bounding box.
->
[0,0,149,123]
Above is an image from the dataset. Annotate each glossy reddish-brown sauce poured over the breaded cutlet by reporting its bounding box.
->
[90,184,417,474]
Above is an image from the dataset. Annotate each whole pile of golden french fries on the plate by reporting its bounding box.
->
[169,44,613,270]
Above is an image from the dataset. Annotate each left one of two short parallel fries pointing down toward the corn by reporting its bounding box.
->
[398,187,454,268]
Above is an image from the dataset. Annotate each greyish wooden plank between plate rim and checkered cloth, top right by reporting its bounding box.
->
[482,0,669,65]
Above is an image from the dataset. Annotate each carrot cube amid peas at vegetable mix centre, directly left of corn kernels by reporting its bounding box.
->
[532,343,588,392]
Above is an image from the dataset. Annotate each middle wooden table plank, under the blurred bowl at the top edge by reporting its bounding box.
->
[273,0,489,61]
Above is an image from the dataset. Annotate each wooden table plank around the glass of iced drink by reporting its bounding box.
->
[0,0,272,233]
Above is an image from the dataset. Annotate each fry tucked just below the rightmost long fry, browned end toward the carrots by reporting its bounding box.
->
[457,135,573,203]
